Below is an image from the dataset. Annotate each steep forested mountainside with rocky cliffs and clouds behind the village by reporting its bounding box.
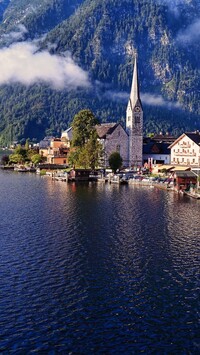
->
[0,0,200,144]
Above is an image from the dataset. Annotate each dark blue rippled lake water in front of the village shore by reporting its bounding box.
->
[0,171,200,355]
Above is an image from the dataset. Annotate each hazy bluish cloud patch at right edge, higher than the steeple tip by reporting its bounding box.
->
[176,19,200,44]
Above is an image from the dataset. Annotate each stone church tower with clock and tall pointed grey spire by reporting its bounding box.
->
[126,56,143,167]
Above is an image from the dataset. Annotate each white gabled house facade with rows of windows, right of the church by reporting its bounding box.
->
[169,131,200,168]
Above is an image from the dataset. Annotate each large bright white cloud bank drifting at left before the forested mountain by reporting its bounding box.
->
[0,42,90,89]
